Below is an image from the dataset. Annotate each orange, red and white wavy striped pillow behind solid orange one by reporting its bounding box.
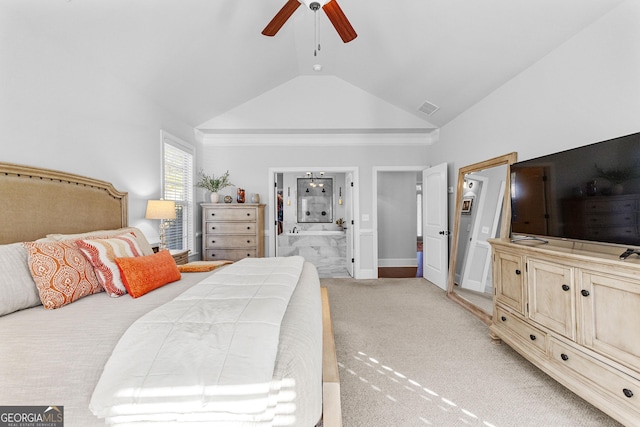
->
[76,233,142,297]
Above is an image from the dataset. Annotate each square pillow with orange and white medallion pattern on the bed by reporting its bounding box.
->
[24,240,104,309]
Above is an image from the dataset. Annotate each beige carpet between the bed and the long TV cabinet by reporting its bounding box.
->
[321,278,619,427]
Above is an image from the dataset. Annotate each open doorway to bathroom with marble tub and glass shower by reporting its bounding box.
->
[269,167,357,277]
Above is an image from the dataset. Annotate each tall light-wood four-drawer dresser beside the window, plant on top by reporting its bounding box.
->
[201,203,265,261]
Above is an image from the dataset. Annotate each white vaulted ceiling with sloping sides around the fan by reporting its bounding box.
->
[0,0,622,127]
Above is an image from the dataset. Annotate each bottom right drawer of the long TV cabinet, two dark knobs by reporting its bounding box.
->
[550,338,640,411]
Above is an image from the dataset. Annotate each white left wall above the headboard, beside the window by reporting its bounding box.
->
[0,11,200,242]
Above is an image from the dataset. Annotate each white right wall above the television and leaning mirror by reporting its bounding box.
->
[427,0,640,229]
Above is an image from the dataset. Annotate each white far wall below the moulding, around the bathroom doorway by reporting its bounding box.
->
[198,134,427,278]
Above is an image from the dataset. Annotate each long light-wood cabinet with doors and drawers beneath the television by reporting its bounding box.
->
[490,239,640,426]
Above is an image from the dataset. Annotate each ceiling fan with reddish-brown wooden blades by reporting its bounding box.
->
[262,0,358,43]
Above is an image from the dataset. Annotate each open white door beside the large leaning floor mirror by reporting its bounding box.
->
[422,163,449,289]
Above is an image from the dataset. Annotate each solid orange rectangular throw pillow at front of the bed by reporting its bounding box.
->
[115,250,181,298]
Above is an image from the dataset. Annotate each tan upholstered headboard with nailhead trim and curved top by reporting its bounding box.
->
[0,163,128,244]
